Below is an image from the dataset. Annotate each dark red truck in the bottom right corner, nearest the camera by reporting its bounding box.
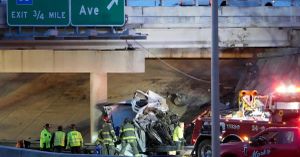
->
[221,127,300,157]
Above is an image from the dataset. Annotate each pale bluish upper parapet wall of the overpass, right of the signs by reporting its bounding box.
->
[126,6,300,28]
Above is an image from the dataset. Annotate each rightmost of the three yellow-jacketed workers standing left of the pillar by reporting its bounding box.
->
[67,124,83,154]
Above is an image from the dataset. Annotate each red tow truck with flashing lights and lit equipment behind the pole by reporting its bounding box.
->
[191,85,300,157]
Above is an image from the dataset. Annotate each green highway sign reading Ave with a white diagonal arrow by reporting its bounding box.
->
[71,0,125,26]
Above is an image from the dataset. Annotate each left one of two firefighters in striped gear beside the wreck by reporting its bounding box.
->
[97,120,117,155]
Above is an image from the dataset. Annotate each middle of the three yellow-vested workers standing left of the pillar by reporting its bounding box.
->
[52,125,67,153]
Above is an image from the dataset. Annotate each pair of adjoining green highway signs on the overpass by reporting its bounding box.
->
[7,0,125,26]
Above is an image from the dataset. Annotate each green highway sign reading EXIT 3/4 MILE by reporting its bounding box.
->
[7,0,70,26]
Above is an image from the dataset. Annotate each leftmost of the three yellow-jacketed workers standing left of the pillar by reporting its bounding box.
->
[40,123,52,151]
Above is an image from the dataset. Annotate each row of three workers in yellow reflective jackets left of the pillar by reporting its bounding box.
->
[40,124,83,154]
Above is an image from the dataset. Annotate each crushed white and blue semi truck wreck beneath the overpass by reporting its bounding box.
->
[100,90,179,155]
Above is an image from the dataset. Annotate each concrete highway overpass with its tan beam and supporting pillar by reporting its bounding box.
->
[0,4,300,140]
